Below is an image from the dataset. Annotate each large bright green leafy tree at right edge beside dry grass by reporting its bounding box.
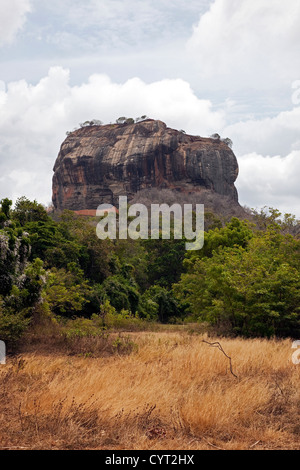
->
[174,229,300,337]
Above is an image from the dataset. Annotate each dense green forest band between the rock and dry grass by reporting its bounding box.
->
[0,197,300,344]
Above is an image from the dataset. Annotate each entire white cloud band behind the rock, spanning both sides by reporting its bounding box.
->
[0,67,300,217]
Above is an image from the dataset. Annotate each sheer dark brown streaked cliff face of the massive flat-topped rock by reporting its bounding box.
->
[53,120,238,210]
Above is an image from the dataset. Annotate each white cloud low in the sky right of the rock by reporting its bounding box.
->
[223,103,300,218]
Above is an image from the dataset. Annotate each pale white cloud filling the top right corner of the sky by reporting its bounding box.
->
[187,0,300,88]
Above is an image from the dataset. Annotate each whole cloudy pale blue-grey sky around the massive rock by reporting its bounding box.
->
[0,0,300,218]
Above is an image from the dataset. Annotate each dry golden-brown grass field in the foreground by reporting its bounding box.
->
[0,331,300,450]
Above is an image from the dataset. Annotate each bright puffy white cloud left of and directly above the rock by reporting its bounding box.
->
[0,67,225,204]
